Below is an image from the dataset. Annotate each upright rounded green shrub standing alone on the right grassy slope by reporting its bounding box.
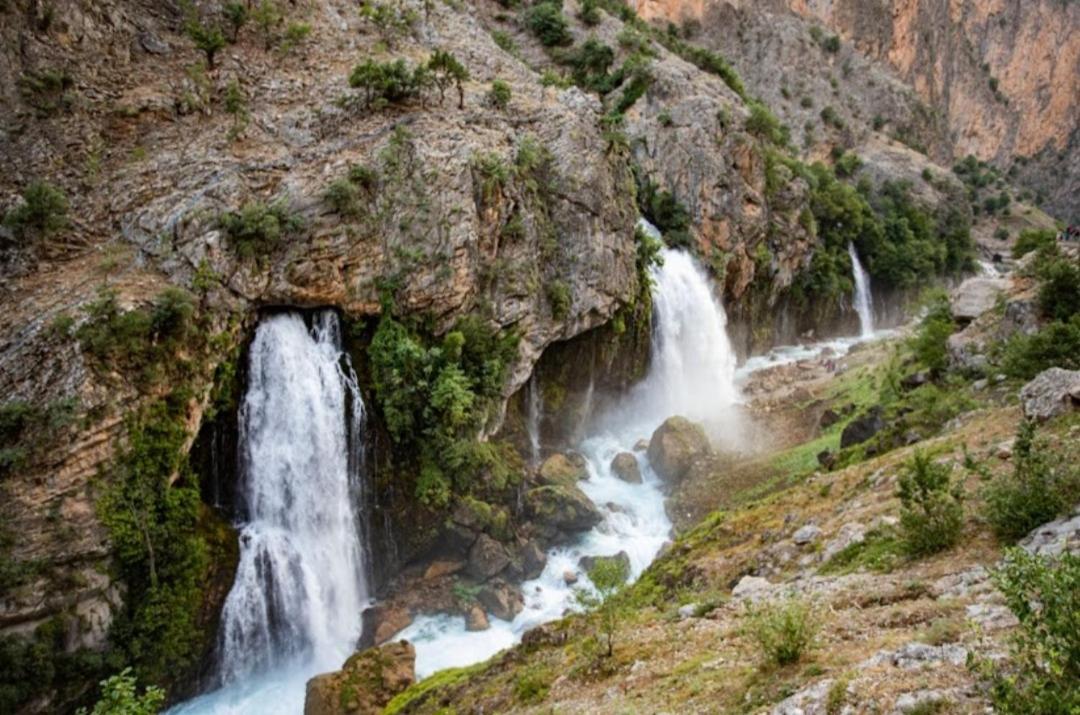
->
[896,451,963,556]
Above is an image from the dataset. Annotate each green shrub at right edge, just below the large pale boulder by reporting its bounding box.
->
[984,420,1080,541]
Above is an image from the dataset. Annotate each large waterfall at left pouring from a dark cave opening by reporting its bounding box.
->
[173,311,369,714]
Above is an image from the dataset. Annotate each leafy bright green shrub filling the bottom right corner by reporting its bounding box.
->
[989,549,1080,715]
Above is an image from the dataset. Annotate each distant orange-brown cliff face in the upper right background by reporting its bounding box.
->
[636,0,1080,220]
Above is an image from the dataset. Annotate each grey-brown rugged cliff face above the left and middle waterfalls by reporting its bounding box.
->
[0,0,842,710]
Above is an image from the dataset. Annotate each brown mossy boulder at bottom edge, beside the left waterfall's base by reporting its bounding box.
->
[303,640,416,715]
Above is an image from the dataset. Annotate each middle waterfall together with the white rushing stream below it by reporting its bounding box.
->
[394,240,738,677]
